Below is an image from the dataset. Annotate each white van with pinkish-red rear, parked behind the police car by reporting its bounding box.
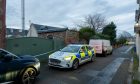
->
[89,39,113,56]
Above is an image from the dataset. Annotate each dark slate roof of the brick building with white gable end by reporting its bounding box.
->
[31,23,68,33]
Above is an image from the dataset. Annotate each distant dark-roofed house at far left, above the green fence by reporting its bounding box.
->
[6,28,28,38]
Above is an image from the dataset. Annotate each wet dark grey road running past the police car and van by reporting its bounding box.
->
[36,46,131,84]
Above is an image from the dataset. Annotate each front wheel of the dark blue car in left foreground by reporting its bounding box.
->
[19,67,37,84]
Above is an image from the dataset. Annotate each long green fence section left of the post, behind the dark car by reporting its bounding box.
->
[6,38,54,55]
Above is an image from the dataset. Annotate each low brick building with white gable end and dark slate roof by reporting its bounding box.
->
[27,23,79,44]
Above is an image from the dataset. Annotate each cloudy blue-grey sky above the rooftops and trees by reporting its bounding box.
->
[6,0,138,34]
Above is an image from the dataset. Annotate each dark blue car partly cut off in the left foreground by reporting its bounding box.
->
[0,49,40,84]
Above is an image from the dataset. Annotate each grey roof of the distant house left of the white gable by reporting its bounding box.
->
[6,28,28,36]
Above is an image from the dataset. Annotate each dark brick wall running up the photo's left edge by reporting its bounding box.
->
[0,0,6,48]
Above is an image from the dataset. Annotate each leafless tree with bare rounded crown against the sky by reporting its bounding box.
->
[85,14,106,32]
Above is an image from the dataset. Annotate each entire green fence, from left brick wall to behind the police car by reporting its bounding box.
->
[6,37,65,62]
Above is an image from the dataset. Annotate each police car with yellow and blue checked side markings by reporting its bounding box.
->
[48,44,96,69]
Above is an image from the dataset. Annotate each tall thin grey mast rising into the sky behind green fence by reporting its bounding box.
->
[21,0,25,36]
